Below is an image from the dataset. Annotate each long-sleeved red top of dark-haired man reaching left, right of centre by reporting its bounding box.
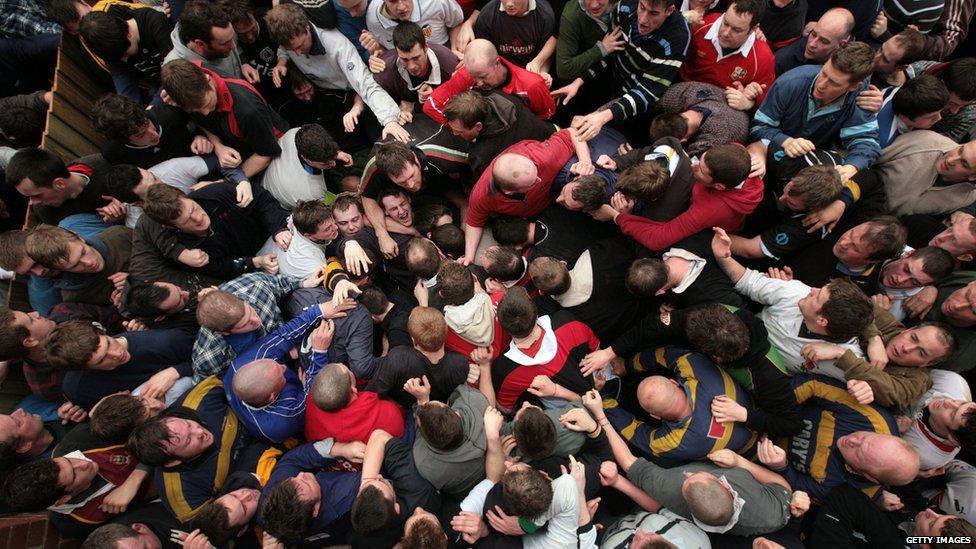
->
[617,177,763,251]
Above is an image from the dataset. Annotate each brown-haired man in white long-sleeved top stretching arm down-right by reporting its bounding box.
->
[264,2,410,141]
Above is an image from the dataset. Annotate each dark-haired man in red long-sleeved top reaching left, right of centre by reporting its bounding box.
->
[591,143,763,251]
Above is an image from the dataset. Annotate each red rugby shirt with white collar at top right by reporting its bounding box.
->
[679,13,776,107]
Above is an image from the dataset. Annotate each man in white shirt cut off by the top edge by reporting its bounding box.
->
[360,0,464,51]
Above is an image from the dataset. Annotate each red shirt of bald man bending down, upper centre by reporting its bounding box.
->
[468,130,576,227]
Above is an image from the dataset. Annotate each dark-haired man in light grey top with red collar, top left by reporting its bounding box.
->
[163,0,252,81]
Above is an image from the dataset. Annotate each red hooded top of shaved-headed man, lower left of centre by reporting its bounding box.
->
[305,391,403,442]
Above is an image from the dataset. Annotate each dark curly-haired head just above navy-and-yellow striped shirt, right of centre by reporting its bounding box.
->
[685,303,751,364]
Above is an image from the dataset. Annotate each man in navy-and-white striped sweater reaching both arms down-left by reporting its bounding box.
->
[552,0,691,139]
